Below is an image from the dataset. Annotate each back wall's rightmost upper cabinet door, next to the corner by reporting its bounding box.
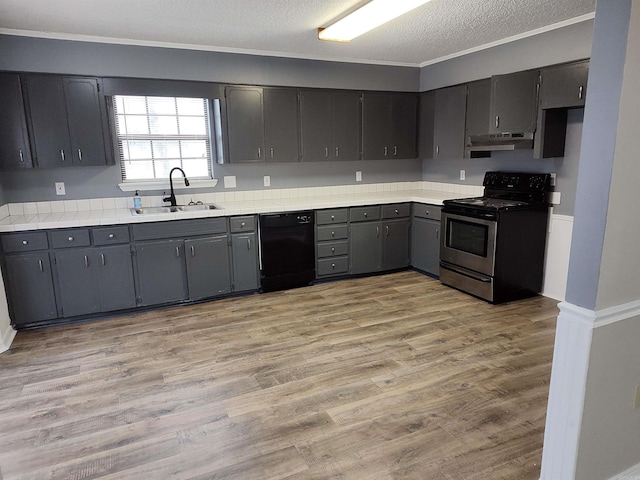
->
[390,94,418,158]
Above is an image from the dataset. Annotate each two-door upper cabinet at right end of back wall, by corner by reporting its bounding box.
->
[362,92,418,160]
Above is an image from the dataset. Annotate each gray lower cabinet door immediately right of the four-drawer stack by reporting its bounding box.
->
[349,222,382,274]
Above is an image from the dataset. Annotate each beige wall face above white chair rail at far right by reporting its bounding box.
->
[596,0,640,310]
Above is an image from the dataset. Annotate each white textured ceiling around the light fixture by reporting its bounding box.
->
[0,0,595,66]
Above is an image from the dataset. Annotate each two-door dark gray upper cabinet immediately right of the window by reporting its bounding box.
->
[225,86,299,163]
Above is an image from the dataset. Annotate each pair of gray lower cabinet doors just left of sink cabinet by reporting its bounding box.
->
[54,245,136,317]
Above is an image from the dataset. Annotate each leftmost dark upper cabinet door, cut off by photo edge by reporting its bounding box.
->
[0,73,33,170]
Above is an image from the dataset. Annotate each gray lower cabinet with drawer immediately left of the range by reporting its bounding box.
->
[411,203,440,276]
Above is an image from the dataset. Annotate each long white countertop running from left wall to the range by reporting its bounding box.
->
[0,190,460,233]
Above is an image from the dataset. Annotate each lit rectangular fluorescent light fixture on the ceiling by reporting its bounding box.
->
[318,0,429,42]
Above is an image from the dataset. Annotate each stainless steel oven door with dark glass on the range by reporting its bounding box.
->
[440,211,498,276]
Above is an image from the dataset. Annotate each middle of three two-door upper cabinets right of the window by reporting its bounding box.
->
[300,90,360,162]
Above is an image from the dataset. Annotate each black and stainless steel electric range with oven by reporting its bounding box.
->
[440,172,550,303]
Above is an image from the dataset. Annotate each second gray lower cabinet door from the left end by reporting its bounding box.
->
[55,248,100,317]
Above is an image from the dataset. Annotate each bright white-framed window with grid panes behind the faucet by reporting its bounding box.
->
[113,95,212,182]
